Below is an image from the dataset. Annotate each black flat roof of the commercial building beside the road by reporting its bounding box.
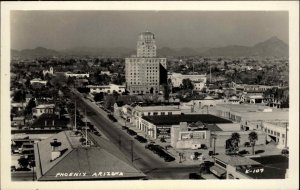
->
[142,114,232,125]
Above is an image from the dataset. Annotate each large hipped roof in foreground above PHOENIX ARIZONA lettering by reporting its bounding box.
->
[34,131,145,181]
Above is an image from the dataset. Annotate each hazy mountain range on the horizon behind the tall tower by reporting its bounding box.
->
[11,37,289,58]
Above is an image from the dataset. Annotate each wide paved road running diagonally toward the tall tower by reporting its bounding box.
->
[68,88,198,179]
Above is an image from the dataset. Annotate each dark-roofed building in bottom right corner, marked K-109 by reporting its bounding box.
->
[210,155,289,179]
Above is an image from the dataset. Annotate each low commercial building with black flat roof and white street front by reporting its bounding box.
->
[139,114,232,139]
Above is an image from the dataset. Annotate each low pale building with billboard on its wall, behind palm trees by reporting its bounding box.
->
[171,122,266,149]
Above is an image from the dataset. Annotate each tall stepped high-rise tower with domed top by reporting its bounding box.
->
[125,31,167,94]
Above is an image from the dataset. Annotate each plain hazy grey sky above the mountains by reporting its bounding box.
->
[10,11,289,50]
